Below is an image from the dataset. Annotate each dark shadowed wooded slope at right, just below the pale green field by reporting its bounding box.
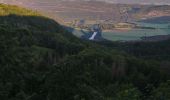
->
[100,39,170,61]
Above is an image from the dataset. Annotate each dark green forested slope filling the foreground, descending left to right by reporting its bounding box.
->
[0,5,170,100]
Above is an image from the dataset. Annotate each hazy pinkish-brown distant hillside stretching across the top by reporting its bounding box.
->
[1,0,170,23]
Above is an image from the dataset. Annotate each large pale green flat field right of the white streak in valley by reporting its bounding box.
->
[103,29,170,41]
